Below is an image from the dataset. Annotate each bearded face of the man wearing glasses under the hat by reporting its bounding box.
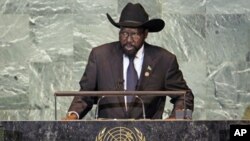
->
[119,27,148,56]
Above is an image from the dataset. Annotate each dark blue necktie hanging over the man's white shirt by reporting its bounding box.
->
[127,57,138,103]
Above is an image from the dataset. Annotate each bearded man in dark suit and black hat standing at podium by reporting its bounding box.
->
[66,3,193,119]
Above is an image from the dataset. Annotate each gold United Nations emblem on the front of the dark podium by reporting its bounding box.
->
[95,127,146,141]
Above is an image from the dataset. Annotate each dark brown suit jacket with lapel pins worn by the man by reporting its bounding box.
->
[69,42,193,119]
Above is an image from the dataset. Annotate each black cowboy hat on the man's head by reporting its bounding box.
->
[107,3,165,32]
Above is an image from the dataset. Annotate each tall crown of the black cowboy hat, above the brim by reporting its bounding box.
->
[119,3,149,23]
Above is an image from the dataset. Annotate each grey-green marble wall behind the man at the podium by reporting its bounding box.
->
[0,0,250,120]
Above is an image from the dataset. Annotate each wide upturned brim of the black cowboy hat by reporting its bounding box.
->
[107,13,165,32]
